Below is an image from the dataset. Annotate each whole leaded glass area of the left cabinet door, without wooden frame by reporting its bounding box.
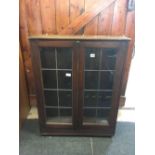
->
[40,44,73,125]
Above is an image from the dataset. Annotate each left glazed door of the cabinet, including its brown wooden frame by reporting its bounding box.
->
[32,41,77,128]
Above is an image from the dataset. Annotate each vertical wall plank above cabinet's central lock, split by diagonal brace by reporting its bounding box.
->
[70,0,84,34]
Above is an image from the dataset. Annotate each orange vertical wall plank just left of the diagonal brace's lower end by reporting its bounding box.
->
[40,0,56,34]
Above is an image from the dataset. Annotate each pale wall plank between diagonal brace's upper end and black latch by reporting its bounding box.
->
[112,0,127,35]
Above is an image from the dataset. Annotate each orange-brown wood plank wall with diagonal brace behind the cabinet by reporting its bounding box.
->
[20,0,135,104]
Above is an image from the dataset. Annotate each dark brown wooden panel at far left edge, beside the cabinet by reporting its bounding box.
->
[19,44,30,128]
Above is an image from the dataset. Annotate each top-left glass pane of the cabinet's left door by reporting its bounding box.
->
[40,48,56,68]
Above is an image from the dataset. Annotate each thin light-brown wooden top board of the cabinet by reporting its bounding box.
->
[29,35,131,41]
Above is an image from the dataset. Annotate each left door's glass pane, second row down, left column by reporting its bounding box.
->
[42,70,57,88]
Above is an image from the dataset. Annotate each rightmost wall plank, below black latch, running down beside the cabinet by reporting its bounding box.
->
[122,11,135,95]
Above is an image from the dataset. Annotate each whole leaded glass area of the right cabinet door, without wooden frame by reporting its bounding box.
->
[83,48,117,125]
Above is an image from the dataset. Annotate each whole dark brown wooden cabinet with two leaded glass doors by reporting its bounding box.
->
[29,35,130,136]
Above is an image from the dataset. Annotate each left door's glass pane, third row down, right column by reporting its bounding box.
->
[59,91,72,107]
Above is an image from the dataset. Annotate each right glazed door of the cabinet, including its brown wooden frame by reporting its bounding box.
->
[79,41,128,129]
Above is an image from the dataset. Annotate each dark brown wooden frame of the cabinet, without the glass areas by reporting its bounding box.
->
[30,36,129,136]
